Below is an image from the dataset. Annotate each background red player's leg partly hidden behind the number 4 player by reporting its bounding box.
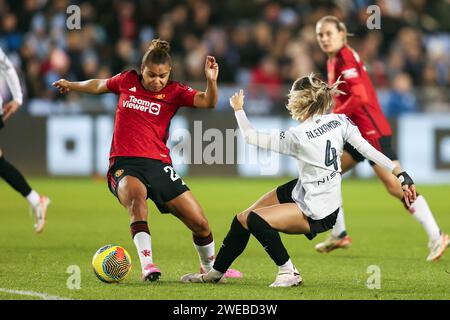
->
[314,150,356,253]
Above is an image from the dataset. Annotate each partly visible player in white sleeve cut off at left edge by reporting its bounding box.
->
[0,48,50,233]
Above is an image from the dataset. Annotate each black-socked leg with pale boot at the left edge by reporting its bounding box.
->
[0,149,50,233]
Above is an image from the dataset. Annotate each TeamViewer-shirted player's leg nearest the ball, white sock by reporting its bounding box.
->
[114,174,161,281]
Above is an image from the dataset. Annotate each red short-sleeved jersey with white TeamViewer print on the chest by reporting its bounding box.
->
[106,70,197,164]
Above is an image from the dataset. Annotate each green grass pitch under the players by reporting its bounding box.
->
[0,178,450,300]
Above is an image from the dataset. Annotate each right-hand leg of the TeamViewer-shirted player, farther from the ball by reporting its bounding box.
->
[166,190,242,278]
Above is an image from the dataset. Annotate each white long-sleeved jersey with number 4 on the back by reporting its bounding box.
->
[235,111,395,220]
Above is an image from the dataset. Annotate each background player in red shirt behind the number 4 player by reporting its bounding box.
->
[316,16,450,261]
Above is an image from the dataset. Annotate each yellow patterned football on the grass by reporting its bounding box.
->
[92,244,131,283]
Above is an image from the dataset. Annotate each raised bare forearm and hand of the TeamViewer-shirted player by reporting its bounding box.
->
[194,56,219,108]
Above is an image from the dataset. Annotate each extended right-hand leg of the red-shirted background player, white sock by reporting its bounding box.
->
[373,161,450,261]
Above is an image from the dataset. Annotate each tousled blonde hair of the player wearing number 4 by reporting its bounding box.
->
[286,73,345,121]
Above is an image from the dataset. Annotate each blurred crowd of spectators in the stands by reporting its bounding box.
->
[0,0,450,117]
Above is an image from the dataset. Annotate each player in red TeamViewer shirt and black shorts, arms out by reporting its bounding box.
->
[53,39,241,281]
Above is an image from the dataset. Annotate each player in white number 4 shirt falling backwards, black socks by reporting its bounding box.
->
[181,74,416,287]
